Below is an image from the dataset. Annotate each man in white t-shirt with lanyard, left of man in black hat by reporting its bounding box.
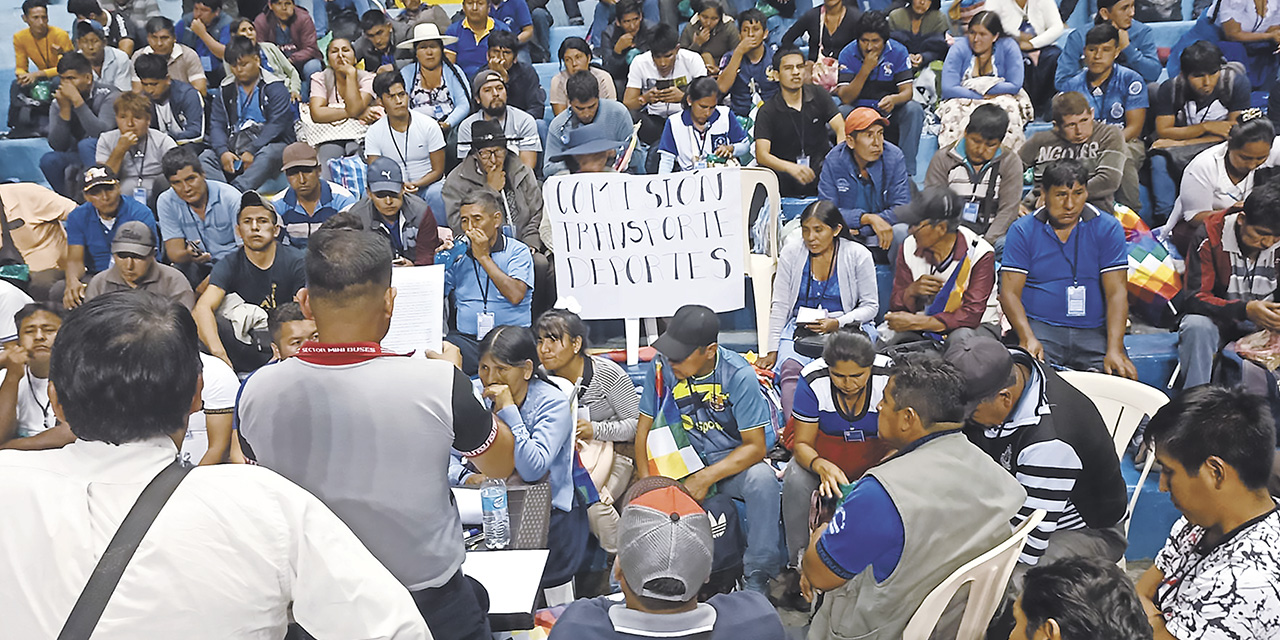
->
[365,72,448,218]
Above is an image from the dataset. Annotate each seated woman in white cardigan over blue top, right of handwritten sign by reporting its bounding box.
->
[756,200,879,419]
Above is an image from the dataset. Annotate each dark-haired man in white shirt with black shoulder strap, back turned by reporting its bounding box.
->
[0,292,431,640]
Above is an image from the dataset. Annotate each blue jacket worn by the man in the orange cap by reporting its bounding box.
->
[818,142,911,243]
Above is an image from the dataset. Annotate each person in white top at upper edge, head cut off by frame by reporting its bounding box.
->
[986,0,1064,114]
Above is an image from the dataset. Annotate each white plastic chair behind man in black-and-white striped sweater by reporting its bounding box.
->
[1059,371,1169,567]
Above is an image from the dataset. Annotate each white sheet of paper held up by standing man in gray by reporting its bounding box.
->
[383,265,444,353]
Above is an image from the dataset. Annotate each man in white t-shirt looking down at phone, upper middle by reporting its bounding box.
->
[622,24,707,167]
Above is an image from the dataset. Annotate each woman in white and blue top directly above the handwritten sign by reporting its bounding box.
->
[658,76,751,173]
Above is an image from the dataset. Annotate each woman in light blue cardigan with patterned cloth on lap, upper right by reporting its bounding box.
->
[942,12,1023,100]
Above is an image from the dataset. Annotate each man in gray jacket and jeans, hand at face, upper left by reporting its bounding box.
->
[40,51,120,197]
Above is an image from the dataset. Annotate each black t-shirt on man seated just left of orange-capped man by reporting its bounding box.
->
[755,84,838,197]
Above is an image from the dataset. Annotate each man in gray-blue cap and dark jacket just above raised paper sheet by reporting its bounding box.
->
[348,156,440,266]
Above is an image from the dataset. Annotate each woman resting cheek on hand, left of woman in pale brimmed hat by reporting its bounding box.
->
[308,38,383,180]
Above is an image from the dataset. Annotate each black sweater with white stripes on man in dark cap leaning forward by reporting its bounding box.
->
[965,349,1128,564]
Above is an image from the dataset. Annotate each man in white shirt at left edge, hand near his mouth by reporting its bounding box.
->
[0,303,64,451]
